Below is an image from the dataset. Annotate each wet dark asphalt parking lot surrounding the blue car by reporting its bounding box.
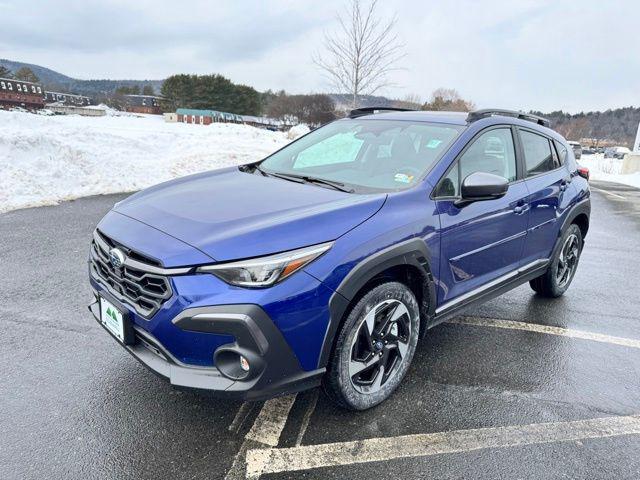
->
[0,183,640,479]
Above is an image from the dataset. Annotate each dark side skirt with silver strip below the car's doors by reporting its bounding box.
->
[429,259,549,328]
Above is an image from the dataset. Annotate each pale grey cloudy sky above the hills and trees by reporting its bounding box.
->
[0,0,640,112]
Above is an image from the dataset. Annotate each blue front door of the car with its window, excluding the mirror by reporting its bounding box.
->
[436,126,528,305]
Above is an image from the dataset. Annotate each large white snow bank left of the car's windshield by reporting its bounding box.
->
[0,111,288,212]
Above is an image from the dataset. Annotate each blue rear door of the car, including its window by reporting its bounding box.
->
[518,128,572,264]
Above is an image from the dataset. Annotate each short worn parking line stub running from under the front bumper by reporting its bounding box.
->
[224,395,296,480]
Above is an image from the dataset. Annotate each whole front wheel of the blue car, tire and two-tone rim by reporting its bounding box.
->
[324,282,420,410]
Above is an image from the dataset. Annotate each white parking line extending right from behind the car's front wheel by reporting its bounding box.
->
[448,317,640,348]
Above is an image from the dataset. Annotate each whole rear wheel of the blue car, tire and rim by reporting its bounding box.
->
[529,223,583,298]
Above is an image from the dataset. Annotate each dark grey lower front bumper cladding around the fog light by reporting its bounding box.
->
[89,292,325,400]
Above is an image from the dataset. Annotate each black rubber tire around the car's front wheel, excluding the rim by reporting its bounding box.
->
[329,282,420,410]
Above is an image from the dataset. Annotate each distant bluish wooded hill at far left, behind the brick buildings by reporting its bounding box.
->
[0,59,163,101]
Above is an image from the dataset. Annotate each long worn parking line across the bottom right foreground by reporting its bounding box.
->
[247,415,640,478]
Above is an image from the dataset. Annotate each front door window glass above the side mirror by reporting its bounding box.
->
[436,128,516,197]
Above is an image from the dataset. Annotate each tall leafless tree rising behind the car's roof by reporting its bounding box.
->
[313,0,404,108]
